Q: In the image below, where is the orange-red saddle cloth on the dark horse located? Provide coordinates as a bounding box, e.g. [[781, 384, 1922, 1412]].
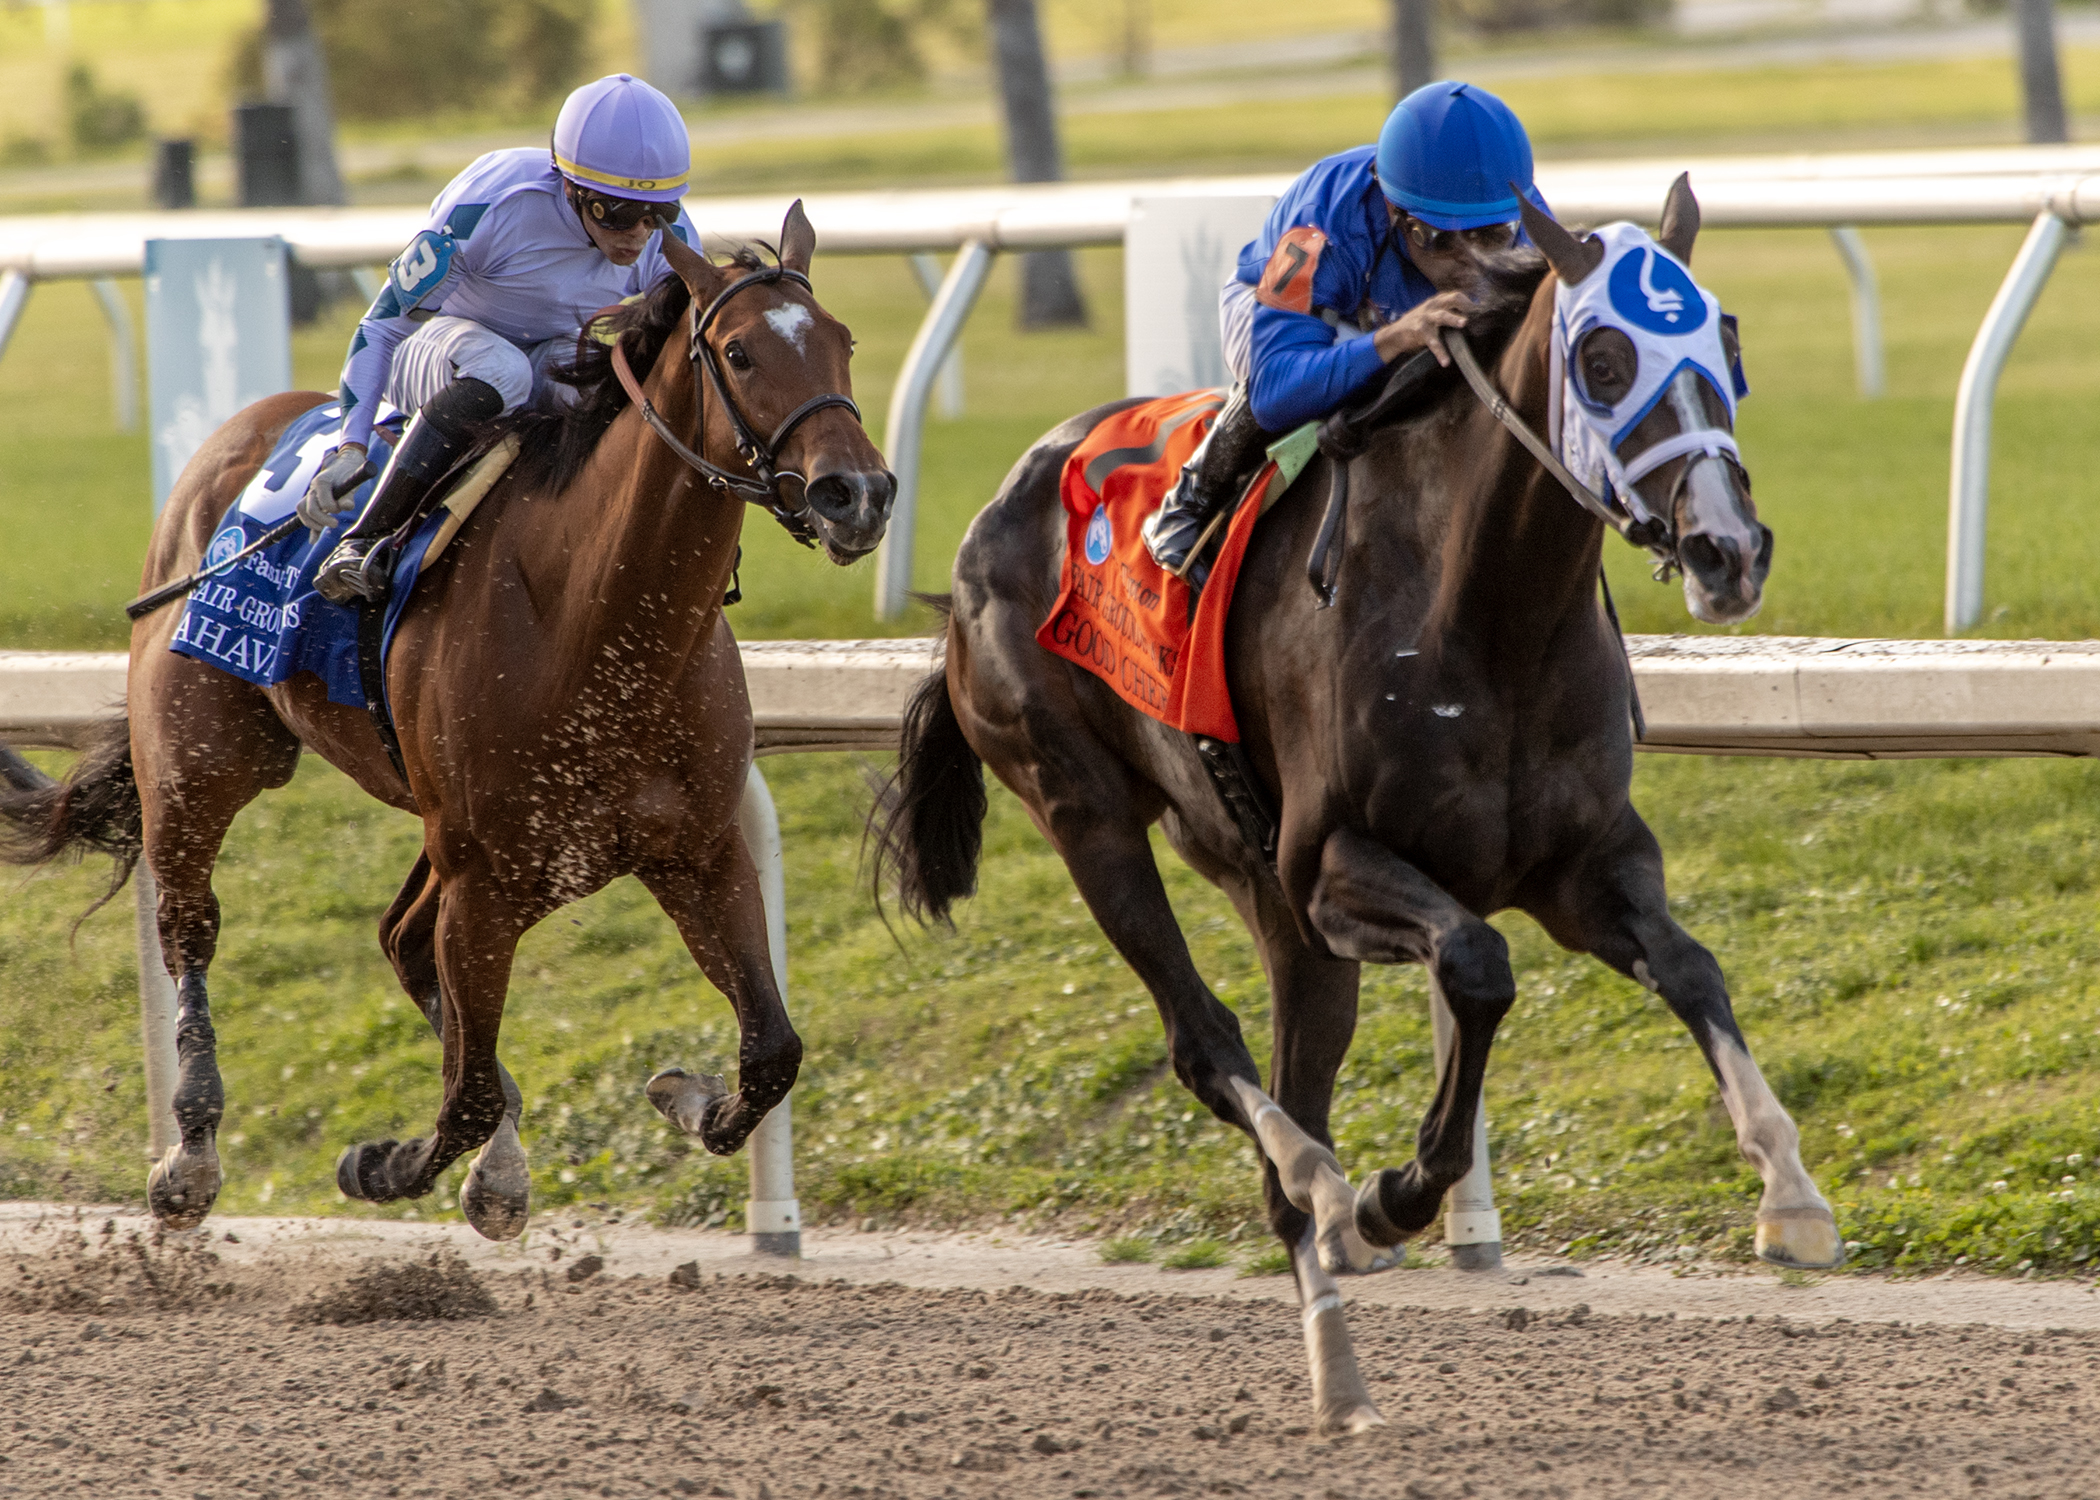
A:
[[1035, 391, 1277, 744]]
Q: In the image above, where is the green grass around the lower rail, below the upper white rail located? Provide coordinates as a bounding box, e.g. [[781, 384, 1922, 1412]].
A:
[[0, 152, 2100, 1273]]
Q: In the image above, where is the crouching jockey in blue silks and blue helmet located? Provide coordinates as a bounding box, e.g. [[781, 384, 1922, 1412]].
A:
[[1145, 82, 1546, 574]]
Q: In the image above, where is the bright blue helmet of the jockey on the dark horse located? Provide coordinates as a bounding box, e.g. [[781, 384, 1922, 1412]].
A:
[[1378, 82, 1537, 229]]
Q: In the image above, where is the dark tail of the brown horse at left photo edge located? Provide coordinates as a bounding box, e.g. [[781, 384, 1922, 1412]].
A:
[[0, 718, 145, 920]]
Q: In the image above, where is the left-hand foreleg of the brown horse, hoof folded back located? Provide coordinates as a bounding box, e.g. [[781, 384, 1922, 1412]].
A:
[[336, 870, 531, 1227]]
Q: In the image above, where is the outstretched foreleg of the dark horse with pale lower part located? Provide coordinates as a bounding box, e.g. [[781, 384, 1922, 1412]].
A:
[[1533, 807, 1844, 1269]]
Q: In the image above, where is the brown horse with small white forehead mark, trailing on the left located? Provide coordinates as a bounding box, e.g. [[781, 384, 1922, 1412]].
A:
[[0, 204, 895, 1237]]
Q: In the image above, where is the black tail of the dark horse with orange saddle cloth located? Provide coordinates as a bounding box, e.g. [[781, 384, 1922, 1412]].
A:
[[867, 599, 985, 926]]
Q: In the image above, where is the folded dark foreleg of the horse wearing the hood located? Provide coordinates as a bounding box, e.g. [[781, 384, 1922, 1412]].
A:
[[1308, 828, 1516, 1246]]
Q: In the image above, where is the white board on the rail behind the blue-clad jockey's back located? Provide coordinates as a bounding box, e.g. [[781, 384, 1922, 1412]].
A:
[[1124, 197, 1277, 395]]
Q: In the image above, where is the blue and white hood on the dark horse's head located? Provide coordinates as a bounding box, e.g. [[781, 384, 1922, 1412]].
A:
[[1548, 223, 1749, 521]]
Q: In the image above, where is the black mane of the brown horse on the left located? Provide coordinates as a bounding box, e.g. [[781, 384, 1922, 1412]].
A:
[[477, 246, 767, 494]]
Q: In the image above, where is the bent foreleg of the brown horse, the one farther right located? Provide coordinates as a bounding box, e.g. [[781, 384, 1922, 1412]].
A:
[[636, 826, 802, 1155]]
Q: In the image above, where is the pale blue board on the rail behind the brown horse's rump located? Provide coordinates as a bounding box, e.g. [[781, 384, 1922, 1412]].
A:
[[145, 239, 292, 515]]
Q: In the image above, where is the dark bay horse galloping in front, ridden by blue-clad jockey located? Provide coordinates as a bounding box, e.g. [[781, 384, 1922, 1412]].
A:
[[876, 181, 1842, 1431]]
